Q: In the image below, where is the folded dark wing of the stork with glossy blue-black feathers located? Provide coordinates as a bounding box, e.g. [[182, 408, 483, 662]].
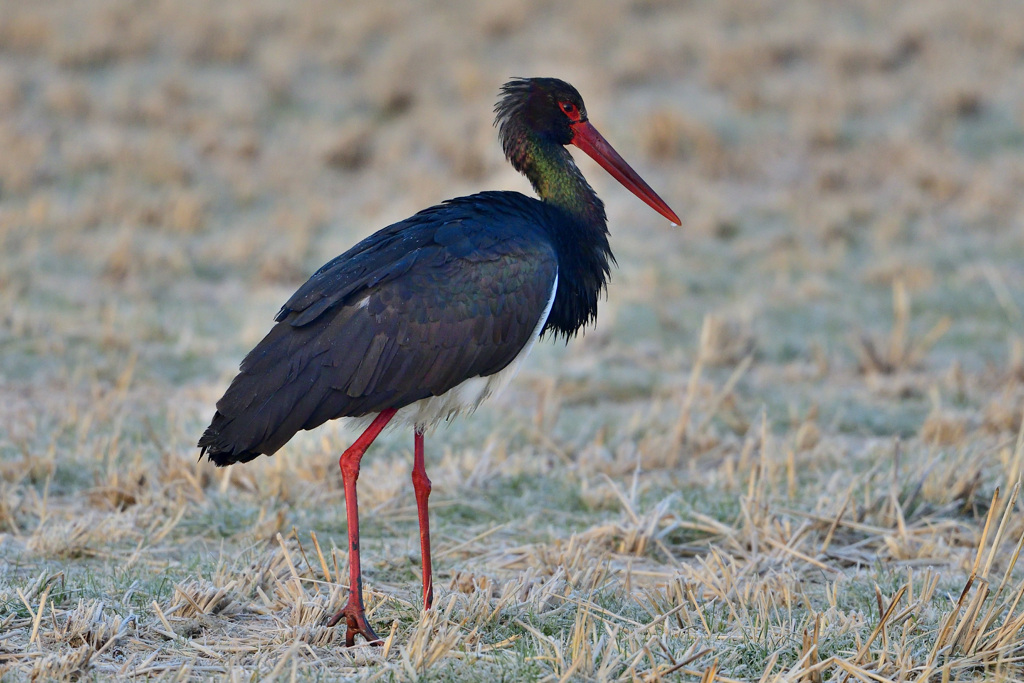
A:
[[199, 193, 557, 465]]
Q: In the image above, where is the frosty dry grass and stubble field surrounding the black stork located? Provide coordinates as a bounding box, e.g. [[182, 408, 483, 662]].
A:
[[0, 0, 1024, 683]]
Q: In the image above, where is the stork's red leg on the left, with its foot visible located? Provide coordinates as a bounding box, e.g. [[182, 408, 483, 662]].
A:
[[327, 408, 397, 647]]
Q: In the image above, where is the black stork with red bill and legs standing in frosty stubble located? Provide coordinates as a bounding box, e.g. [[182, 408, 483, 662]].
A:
[[198, 78, 681, 646]]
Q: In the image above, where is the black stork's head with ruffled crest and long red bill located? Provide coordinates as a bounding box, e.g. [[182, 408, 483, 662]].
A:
[[495, 78, 681, 225]]
